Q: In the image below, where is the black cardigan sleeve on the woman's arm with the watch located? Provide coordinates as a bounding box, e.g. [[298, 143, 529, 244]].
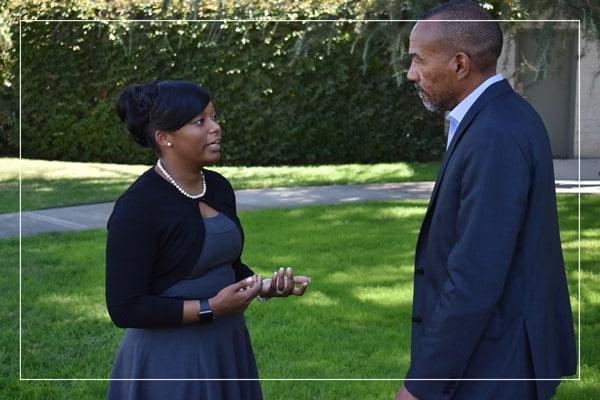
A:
[[106, 201, 183, 328]]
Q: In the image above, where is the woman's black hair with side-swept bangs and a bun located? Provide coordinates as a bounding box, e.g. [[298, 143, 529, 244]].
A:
[[117, 81, 210, 151]]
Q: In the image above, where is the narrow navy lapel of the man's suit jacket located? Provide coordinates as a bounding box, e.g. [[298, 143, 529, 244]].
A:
[[417, 79, 512, 260]]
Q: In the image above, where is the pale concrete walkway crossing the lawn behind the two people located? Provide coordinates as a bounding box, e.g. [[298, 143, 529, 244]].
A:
[[0, 181, 600, 238]]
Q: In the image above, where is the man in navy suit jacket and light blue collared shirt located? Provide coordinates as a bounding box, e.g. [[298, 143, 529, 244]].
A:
[[396, 0, 576, 400]]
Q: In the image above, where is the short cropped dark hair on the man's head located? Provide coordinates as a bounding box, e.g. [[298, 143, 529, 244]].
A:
[[420, 0, 503, 71]]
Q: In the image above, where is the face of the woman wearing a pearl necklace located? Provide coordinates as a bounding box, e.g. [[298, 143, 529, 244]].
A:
[[170, 102, 221, 166]]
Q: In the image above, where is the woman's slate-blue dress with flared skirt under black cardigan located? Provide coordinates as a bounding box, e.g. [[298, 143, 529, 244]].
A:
[[107, 213, 262, 400]]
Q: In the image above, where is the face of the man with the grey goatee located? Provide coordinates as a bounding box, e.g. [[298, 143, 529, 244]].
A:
[[407, 21, 458, 111]]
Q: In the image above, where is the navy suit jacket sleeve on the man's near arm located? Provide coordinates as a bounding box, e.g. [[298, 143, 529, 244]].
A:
[[405, 129, 531, 399]]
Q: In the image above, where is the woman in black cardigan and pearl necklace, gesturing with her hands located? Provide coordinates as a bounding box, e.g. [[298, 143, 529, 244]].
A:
[[106, 81, 310, 400]]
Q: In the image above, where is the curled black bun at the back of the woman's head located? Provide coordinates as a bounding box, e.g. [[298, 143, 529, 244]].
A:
[[117, 83, 158, 147]]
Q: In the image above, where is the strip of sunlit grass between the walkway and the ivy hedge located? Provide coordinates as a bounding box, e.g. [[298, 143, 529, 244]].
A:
[[0, 158, 438, 213]]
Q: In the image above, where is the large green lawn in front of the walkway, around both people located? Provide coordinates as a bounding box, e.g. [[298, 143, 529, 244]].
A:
[[0, 195, 600, 400]]
